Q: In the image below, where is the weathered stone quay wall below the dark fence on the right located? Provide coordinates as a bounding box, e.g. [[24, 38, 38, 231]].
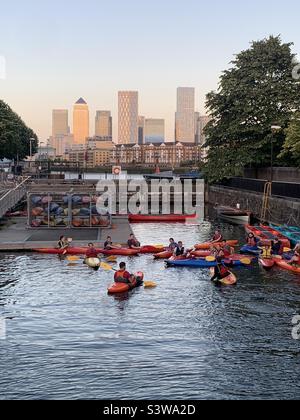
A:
[[206, 186, 300, 226]]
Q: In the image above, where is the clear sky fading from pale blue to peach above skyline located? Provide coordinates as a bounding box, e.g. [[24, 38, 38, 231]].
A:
[[0, 0, 300, 141]]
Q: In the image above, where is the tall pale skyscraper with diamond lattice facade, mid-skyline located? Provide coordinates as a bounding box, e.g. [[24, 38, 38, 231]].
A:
[[118, 91, 139, 144]]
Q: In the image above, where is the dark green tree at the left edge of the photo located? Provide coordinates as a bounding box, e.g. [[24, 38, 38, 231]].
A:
[[0, 100, 38, 160]]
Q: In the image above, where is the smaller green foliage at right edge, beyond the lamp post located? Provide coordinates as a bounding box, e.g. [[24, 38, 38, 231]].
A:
[[281, 112, 300, 167]]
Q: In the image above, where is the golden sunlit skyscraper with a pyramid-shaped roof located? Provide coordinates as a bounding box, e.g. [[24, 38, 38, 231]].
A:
[[73, 98, 90, 144]]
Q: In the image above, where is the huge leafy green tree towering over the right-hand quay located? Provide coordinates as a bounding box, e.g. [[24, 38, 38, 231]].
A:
[[205, 36, 300, 182]]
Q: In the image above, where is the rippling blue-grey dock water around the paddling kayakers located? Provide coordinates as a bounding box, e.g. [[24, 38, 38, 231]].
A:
[[0, 222, 300, 399]]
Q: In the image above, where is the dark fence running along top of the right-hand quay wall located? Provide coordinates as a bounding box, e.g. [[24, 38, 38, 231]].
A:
[[218, 178, 300, 199]]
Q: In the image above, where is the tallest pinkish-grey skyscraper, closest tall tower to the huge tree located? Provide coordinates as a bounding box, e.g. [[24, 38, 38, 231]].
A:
[[175, 87, 195, 143]]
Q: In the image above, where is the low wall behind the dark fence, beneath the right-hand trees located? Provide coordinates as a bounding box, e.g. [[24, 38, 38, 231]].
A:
[[244, 168, 300, 183]]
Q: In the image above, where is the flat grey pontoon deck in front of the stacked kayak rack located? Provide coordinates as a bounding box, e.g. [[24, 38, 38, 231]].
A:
[[0, 217, 132, 252]]
